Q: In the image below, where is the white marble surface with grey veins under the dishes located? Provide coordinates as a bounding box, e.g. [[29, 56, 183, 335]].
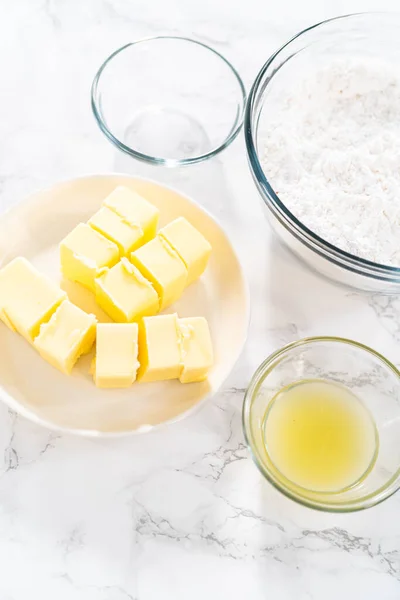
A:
[[0, 0, 400, 600]]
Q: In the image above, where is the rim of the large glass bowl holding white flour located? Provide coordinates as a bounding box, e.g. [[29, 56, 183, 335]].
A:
[[244, 11, 400, 284]]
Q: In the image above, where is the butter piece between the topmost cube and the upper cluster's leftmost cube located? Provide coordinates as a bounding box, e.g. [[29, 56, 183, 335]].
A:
[[88, 206, 143, 256]]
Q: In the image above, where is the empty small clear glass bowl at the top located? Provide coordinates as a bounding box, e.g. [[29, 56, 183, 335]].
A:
[[92, 36, 246, 167]]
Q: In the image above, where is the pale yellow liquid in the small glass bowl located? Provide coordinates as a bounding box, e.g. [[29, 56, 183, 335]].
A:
[[263, 379, 378, 493]]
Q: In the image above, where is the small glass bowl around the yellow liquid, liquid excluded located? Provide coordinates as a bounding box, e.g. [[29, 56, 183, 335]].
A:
[[243, 337, 400, 512]]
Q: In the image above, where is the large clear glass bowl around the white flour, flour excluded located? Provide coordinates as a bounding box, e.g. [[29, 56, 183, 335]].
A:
[[244, 13, 400, 292]]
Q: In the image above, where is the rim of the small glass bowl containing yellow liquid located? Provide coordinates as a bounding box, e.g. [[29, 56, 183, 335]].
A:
[[242, 336, 400, 513]]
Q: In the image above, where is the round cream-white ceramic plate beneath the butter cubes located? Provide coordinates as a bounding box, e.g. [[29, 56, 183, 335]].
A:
[[0, 175, 249, 435]]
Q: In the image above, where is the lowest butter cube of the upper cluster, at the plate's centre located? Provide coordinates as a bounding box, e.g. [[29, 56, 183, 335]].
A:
[[95, 258, 160, 323]]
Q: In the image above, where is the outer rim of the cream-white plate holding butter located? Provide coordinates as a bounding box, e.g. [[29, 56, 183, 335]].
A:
[[0, 171, 251, 439]]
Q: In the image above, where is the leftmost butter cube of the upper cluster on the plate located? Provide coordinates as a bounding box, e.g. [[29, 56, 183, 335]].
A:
[[60, 223, 119, 292]]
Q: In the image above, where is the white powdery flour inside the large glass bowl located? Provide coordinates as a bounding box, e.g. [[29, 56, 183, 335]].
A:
[[262, 61, 400, 266]]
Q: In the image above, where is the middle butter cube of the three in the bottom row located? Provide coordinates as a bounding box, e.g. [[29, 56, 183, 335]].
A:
[[138, 314, 182, 382]]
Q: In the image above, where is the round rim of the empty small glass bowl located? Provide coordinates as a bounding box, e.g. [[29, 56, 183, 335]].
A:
[[91, 35, 246, 167]]
